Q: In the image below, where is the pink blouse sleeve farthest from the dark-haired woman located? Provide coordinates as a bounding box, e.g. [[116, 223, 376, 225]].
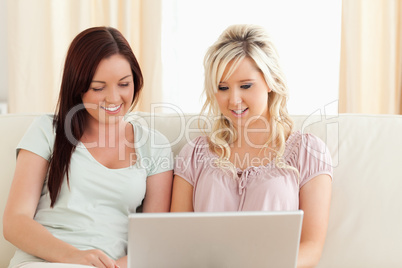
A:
[[299, 134, 333, 188]]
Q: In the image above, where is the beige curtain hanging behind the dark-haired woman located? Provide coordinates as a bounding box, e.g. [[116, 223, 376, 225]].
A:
[[7, 0, 161, 113]]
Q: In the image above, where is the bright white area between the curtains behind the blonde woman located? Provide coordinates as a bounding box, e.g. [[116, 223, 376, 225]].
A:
[[162, 0, 342, 114]]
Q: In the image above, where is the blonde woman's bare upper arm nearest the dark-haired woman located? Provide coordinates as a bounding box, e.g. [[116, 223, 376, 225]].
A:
[[170, 175, 194, 212]]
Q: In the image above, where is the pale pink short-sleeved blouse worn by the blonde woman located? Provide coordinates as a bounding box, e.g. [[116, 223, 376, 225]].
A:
[[174, 131, 332, 212]]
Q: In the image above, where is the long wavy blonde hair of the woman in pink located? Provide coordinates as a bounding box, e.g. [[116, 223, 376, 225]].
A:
[[201, 24, 293, 175]]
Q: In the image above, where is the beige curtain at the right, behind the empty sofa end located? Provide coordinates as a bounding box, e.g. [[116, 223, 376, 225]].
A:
[[339, 0, 402, 114]]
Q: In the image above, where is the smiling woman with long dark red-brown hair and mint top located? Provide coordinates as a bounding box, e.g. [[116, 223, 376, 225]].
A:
[[4, 27, 173, 268]]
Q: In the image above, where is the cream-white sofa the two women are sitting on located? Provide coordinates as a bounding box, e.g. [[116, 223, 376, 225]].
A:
[[0, 113, 402, 268]]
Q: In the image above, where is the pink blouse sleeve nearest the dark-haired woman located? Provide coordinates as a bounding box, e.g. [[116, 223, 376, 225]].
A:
[[174, 137, 204, 186]]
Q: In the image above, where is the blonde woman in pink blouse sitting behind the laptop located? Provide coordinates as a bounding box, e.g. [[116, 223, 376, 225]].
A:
[[171, 25, 332, 267]]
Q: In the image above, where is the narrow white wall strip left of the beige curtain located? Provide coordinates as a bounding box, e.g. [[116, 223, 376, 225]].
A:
[[0, 0, 8, 102]]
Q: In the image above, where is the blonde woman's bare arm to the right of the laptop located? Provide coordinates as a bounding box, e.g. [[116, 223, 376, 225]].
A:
[[297, 174, 332, 268]]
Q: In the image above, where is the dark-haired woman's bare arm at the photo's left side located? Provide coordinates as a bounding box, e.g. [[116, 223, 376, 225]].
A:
[[3, 150, 115, 268]]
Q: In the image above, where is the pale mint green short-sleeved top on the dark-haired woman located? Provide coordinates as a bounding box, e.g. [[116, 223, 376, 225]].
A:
[[10, 115, 173, 267]]
